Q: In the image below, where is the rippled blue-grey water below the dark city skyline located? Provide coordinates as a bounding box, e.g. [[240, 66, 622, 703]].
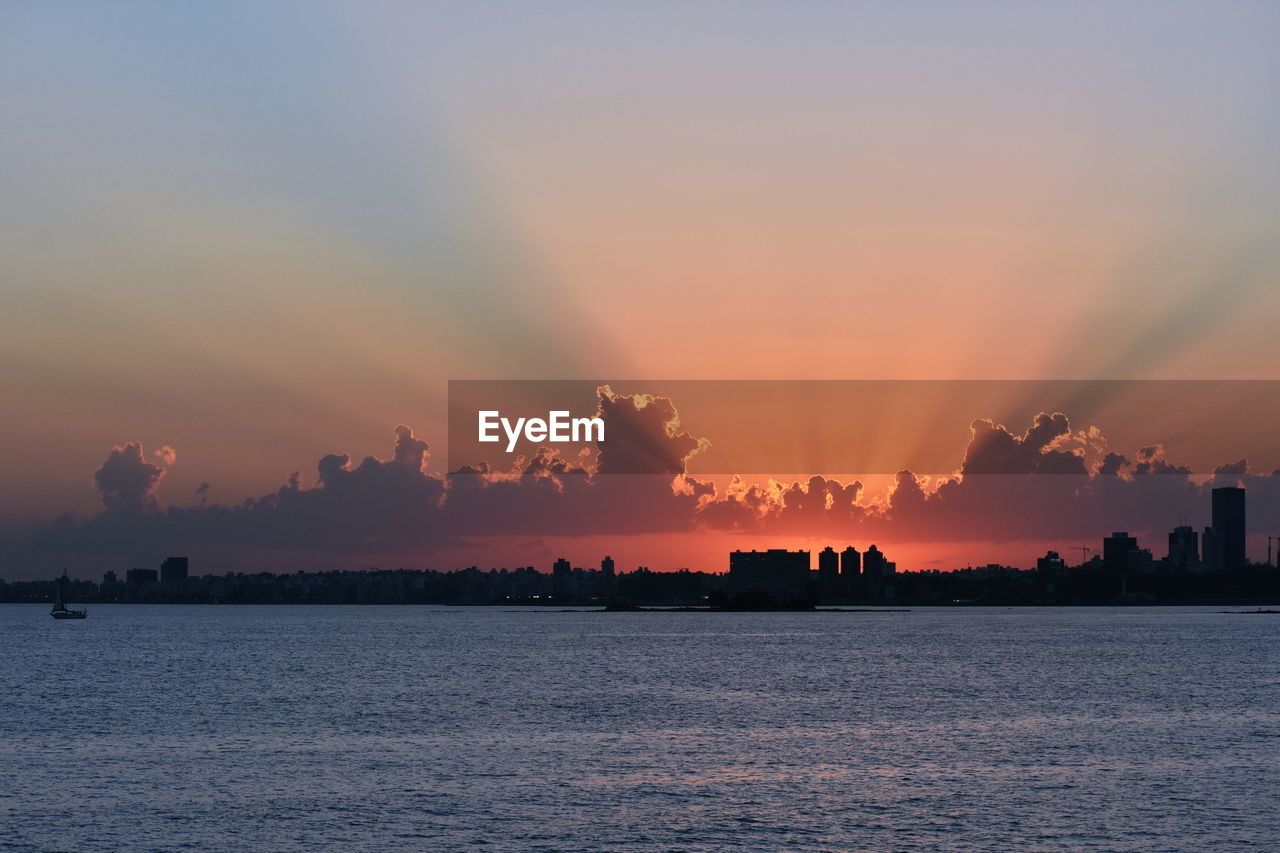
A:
[[0, 605, 1280, 852]]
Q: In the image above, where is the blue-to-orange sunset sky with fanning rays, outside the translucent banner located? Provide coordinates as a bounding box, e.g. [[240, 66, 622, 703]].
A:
[[0, 0, 1280, 575]]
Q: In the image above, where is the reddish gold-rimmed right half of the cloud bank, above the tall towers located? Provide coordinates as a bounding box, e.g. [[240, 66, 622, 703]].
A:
[[698, 412, 1280, 542]]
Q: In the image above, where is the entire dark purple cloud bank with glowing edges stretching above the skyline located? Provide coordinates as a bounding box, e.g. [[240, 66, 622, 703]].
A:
[[9, 388, 1280, 569]]
